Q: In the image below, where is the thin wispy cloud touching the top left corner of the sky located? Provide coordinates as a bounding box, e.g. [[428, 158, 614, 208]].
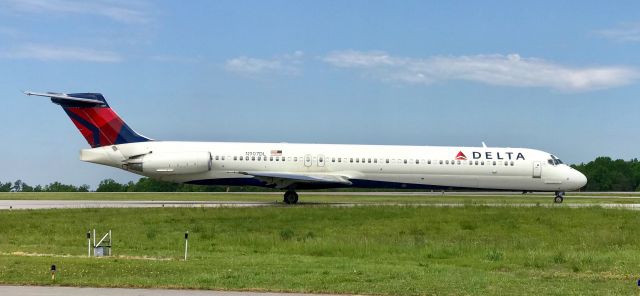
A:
[[6, 0, 150, 23]]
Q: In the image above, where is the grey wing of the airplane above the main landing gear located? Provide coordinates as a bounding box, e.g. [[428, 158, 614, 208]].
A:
[[234, 171, 351, 188]]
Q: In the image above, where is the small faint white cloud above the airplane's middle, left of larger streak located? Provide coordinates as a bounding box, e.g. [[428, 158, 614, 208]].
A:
[[225, 51, 304, 75]]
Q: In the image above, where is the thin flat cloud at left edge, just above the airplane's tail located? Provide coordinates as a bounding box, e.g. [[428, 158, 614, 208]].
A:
[[0, 44, 122, 63]]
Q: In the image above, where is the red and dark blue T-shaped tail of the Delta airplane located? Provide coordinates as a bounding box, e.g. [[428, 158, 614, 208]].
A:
[[25, 92, 151, 148]]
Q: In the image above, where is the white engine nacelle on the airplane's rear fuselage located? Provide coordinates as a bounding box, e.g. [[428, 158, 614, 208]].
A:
[[125, 151, 213, 175]]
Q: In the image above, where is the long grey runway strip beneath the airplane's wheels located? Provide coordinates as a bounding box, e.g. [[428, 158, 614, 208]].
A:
[[0, 200, 640, 210]]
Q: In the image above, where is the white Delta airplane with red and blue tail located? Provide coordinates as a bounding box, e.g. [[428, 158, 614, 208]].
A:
[[24, 92, 587, 204]]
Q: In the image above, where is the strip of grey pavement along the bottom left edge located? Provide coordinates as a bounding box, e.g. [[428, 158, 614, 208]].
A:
[[0, 286, 342, 296]]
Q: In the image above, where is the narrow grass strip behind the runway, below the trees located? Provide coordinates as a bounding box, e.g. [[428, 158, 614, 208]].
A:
[[0, 191, 640, 205]]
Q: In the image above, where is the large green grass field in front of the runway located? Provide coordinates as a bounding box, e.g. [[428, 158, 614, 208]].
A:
[[0, 206, 640, 295]]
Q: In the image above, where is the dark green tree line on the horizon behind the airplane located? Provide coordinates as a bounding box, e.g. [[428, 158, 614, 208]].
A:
[[0, 157, 640, 192]]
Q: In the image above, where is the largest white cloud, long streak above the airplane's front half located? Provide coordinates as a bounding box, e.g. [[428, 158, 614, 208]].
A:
[[323, 50, 639, 91]]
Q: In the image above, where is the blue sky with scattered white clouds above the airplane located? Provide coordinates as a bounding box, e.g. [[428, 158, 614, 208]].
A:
[[0, 0, 640, 189]]
